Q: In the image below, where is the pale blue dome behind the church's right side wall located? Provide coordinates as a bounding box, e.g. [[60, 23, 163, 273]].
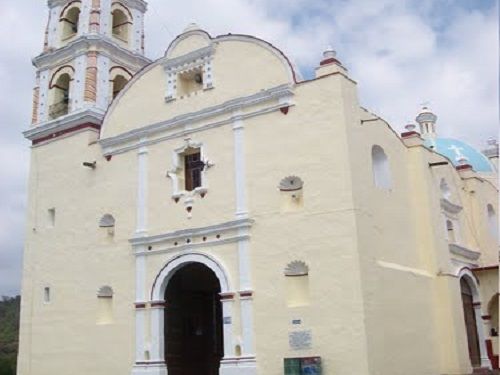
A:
[[425, 138, 494, 172]]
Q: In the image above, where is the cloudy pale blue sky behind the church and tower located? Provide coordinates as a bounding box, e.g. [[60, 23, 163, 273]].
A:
[[0, 0, 499, 296]]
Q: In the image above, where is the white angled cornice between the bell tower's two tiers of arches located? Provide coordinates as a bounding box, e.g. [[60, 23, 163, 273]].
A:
[[32, 34, 151, 69]]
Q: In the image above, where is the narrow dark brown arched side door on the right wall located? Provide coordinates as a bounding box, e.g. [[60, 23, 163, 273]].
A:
[[460, 277, 481, 367]]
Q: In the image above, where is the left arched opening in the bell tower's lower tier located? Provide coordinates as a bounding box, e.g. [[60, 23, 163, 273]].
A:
[[49, 66, 74, 120]]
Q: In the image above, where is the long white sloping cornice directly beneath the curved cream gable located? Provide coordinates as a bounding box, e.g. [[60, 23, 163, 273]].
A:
[[99, 84, 293, 155]]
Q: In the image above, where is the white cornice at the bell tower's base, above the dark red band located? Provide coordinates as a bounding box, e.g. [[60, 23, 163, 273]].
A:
[[23, 108, 104, 141]]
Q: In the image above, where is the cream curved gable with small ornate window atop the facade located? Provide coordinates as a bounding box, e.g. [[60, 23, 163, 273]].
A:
[[101, 29, 297, 140]]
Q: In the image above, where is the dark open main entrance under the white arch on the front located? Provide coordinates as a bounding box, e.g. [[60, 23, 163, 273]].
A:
[[164, 263, 224, 375]]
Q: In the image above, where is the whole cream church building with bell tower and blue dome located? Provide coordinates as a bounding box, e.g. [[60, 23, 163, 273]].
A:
[[18, 0, 499, 375]]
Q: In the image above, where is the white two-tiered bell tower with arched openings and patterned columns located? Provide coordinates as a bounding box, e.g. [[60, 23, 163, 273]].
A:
[[24, 0, 150, 145]]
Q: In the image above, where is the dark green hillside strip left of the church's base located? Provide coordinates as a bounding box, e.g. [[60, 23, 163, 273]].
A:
[[0, 296, 21, 375]]
